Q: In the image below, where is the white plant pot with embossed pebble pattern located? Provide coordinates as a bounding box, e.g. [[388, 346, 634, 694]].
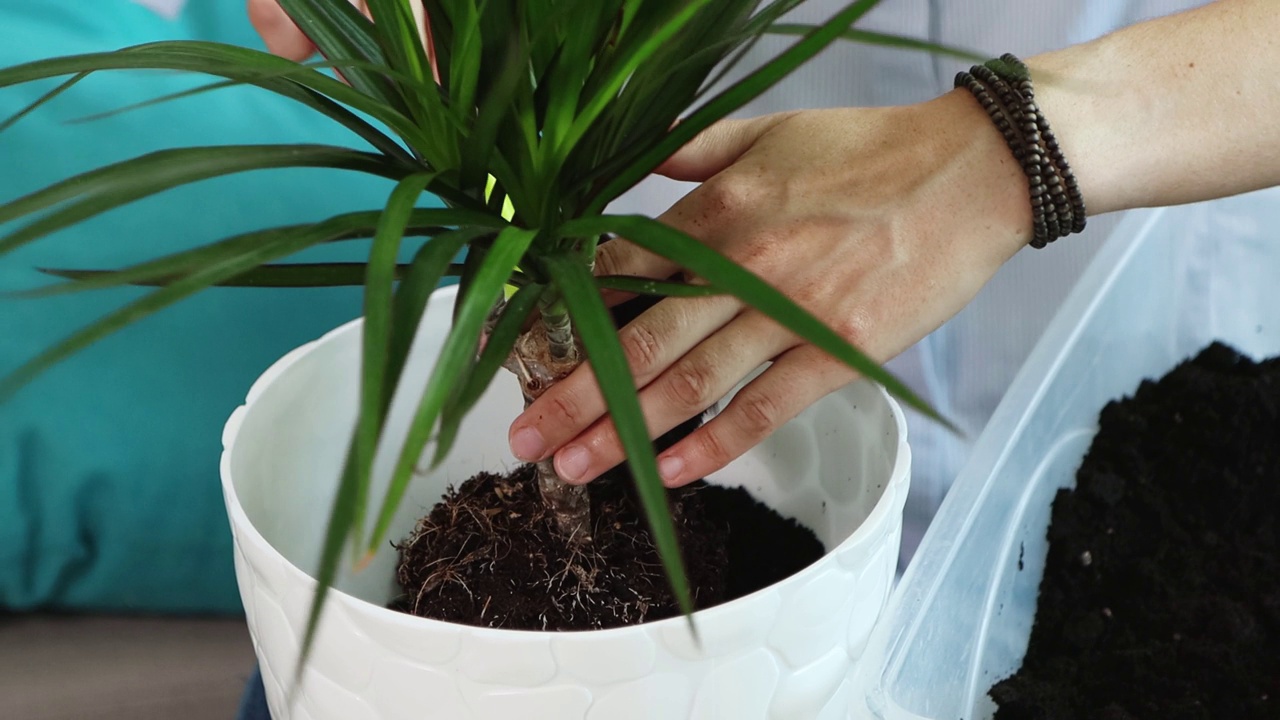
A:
[[221, 287, 910, 720]]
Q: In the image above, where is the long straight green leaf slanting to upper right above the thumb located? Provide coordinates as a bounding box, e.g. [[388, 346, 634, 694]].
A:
[[584, 0, 879, 215]]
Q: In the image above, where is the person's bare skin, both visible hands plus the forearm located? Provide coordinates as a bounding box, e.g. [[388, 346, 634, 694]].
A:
[[250, 0, 1280, 486]]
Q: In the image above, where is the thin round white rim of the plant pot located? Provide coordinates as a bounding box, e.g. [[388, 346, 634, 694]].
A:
[[219, 284, 911, 639]]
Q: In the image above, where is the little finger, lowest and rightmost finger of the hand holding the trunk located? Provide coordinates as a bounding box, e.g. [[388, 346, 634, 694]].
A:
[[658, 346, 856, 487]]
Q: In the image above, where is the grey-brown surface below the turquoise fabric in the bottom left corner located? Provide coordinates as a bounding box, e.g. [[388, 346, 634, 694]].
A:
[[0, 615, 253, 720]]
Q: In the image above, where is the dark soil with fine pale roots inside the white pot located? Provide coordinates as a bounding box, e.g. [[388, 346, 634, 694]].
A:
[[392, 285, 824, 630]]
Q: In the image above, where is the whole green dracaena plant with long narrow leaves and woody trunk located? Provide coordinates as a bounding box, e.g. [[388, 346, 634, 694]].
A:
[[0, 0, 962, 661]]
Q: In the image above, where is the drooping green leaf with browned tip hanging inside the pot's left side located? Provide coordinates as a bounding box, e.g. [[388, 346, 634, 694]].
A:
[[369, 227, 538, 551]]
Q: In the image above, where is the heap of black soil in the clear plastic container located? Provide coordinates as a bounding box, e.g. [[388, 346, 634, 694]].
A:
[[991, 343, 1280, 720]]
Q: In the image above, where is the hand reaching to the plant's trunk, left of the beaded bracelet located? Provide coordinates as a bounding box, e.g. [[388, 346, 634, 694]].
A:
[[509, 91, 1032, 487]]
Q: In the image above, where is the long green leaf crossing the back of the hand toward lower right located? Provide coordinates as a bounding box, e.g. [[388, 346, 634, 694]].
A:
[[558, 215, 955, 429]]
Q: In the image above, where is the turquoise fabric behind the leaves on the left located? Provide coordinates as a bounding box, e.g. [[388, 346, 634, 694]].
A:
[[0, 0, 435, 612]]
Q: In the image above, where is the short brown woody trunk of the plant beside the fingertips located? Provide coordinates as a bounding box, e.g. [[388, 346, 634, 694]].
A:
[[506, 302, 591, 544]]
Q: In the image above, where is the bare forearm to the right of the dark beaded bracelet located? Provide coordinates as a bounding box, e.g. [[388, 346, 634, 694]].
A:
[[1028, 0, 1280, 214]]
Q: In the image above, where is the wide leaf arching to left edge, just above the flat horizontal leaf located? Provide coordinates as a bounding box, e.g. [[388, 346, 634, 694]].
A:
[[0, 145, 406, 255]]
